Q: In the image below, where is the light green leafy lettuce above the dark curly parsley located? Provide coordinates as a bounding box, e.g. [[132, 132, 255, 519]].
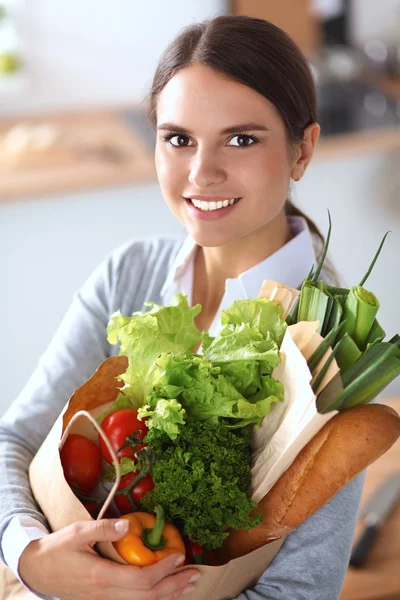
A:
[[107, 294, 286, 439]]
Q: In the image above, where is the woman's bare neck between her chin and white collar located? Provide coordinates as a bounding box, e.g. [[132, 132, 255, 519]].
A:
[[195, 211, 292, 310]]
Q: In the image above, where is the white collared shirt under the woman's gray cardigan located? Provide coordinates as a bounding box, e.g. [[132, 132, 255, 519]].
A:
[[161, 217, 316, 336]]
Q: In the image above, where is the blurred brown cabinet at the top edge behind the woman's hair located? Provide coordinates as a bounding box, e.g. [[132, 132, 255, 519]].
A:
[[230, 0, 321, 57]]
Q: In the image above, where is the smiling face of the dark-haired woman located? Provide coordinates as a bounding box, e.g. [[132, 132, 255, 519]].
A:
[[155, 65, 294, 246]]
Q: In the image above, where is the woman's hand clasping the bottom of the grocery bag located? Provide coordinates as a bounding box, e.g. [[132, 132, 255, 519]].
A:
[[18, 519, 199, 600]]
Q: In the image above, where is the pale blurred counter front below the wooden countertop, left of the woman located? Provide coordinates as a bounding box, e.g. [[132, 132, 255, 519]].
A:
[[0, 185, 183, 415]]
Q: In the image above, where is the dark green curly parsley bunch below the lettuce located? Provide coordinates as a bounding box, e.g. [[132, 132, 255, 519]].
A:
[[142, 418, 262, 548]]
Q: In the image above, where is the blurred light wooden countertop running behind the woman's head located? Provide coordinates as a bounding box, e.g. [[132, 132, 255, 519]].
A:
[[0, 78, 400, 202]]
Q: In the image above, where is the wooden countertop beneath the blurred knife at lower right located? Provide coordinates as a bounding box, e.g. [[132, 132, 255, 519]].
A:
[[339, 398, 400, 600]]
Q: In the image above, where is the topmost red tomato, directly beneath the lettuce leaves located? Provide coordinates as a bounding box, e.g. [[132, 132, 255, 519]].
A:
[[99, 408, 148, 464]]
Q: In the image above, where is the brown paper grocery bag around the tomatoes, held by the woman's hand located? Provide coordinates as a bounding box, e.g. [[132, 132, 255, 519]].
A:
[[29, 356, 284, 600]]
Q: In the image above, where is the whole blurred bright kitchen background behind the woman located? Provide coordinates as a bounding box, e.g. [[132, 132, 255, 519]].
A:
[[0, 0, 400, 600]]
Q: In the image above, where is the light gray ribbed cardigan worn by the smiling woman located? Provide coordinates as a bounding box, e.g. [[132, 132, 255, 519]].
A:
[[0, 237, 365, 600]]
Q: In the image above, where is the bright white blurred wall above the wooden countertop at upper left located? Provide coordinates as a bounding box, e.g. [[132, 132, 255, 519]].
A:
[[0, 0, 226, 115]]
